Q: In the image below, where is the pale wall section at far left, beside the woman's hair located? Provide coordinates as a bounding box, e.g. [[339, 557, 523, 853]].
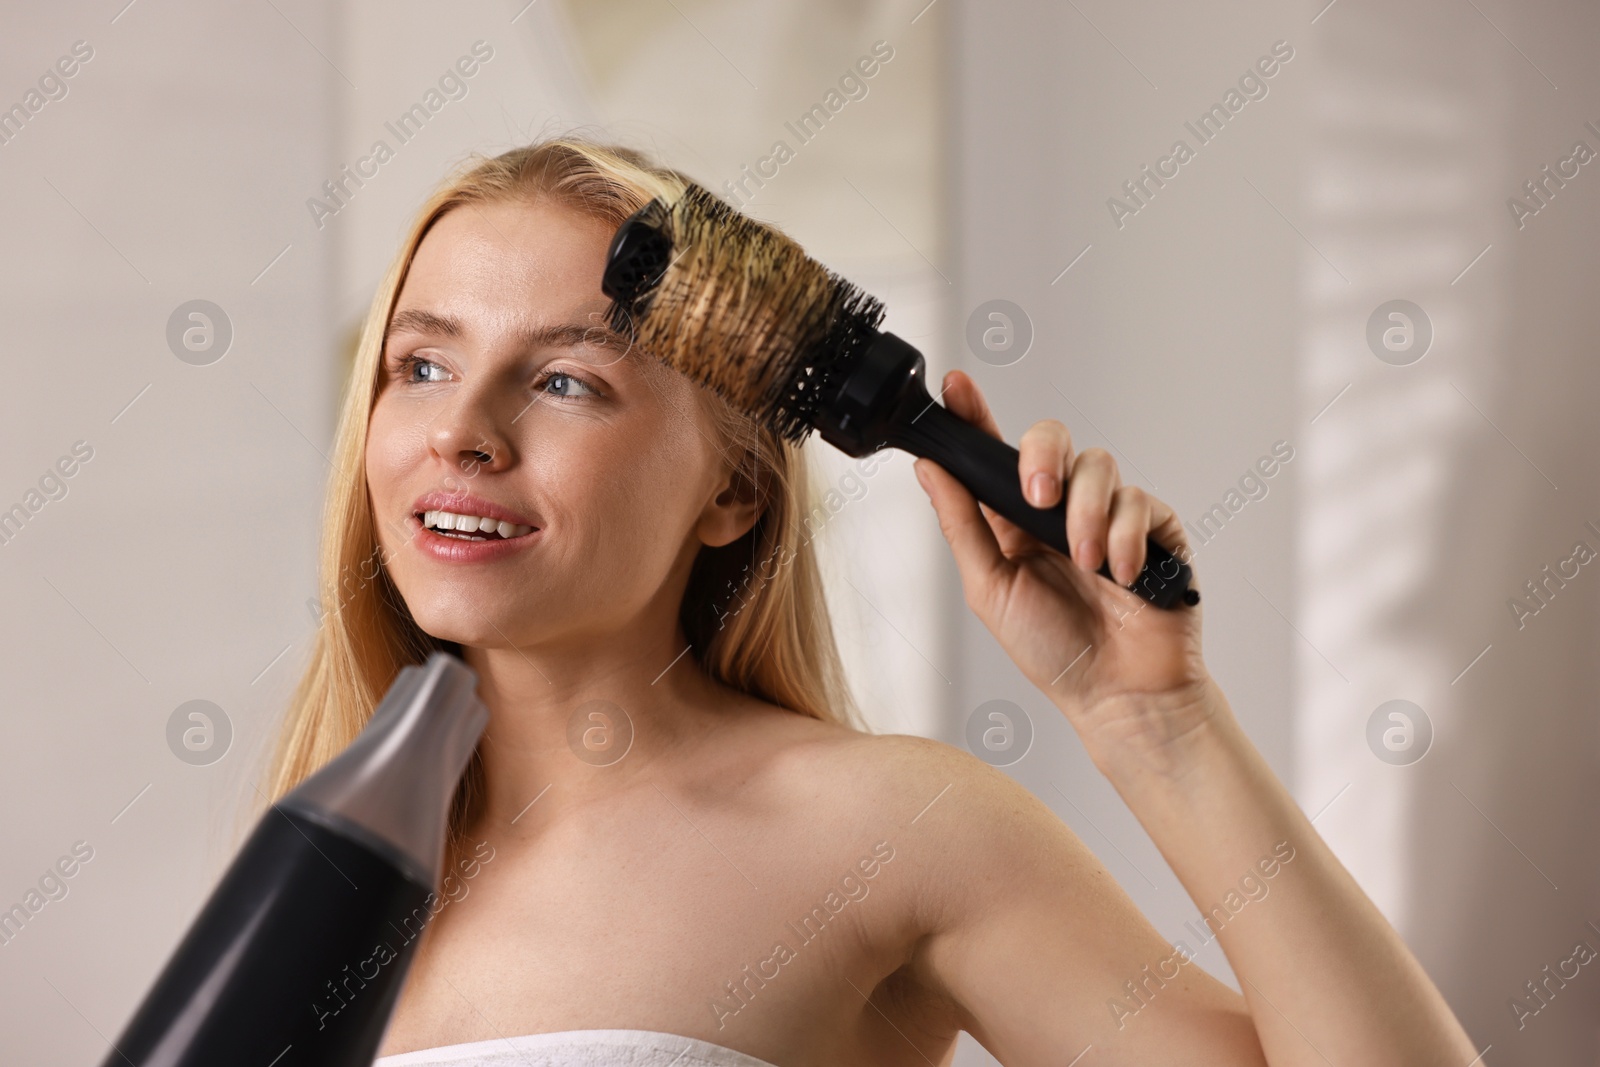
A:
[[0, 0, 344, 1065]]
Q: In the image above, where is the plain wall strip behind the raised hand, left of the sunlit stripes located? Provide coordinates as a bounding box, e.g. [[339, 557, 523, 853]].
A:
[[952, 3, 1315, 1062]]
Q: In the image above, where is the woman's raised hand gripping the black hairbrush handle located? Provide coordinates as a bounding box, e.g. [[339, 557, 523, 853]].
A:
[[914, 371, 1213, 763]]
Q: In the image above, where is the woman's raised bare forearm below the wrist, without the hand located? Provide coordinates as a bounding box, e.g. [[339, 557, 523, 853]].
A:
[[1091, 683, 1477, 1067]]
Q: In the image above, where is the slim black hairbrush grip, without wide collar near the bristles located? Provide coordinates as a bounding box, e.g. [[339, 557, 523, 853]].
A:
[[886, 398, 1200, 608]]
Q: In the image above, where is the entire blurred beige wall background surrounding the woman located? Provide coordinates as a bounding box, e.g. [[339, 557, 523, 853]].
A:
[[0, 0, 1600, 1067]]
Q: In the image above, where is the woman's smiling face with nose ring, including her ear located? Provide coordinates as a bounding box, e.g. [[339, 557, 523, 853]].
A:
[[366, 200, 755, 651]]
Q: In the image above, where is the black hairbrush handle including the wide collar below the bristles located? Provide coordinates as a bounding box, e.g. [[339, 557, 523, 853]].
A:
[[818, 333, 1200, 608]]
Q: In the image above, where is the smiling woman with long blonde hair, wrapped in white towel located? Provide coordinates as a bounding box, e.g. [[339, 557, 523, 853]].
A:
[[262, 141, 1475, 1067]]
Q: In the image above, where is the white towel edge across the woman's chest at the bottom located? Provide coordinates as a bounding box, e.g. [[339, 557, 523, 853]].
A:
[[373, 1030, 776, 1067]]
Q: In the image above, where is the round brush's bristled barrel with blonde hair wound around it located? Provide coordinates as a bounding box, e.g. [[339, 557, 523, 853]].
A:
[[617, 184, 883, 443]]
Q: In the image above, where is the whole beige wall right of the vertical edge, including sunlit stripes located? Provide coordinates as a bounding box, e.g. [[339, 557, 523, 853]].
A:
[[952, 0, 1600, 1067]]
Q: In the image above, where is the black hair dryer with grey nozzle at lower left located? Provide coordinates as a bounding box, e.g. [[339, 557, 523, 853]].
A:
[[102, 653, 488, 1067]]
